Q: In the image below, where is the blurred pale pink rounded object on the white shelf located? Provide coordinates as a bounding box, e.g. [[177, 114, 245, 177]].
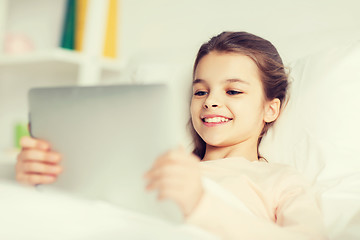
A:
[[4, 34, 34, 54]]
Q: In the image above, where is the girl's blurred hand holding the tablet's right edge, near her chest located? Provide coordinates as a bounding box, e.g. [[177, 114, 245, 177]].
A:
[[145, 148, 204, 216]]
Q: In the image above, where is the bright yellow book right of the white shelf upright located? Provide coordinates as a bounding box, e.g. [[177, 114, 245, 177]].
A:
[[103, 0, 118, 58]]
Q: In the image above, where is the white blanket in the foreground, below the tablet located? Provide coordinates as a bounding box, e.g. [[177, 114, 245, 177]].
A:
[[0, 164, 218, 240]]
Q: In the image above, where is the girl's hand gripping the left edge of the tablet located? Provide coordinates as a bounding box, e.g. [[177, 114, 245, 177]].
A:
[[16, 137, 62, 185]]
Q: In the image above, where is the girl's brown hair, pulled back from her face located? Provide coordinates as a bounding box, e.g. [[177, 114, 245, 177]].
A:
[[189, 32, 288, 159]]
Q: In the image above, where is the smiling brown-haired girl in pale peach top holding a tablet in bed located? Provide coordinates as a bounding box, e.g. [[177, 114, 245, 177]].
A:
[[16, 32, 325, 239]]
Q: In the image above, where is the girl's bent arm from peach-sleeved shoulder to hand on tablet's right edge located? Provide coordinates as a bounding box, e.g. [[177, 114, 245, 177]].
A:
[[146, 149, 326, 240]]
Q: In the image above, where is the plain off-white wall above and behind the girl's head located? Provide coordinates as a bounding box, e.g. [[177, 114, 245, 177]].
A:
[[122, 0, 360, 61]]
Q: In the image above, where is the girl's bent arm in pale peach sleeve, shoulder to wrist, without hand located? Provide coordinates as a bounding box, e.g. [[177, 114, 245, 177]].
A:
[[186, 174, 327, 240]]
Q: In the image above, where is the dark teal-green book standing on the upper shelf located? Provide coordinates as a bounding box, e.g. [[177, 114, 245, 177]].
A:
[[60, 0, 76, 49]]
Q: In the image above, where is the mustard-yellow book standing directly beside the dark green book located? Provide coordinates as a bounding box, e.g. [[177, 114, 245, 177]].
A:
[[75, 0, 88, 51]]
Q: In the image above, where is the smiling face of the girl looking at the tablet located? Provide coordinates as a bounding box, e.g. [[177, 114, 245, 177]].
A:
[[190, 52, 268, 147]]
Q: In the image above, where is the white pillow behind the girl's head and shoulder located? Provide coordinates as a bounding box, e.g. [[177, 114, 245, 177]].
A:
[[260, 41, 360, 185]]
